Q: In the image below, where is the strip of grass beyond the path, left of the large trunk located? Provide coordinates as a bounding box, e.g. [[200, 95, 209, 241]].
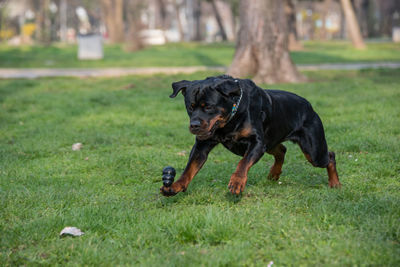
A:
[[0, 43, 234, 68]]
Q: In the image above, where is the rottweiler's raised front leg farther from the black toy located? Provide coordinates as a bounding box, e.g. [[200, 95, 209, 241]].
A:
[[228, 139, 264, 195]]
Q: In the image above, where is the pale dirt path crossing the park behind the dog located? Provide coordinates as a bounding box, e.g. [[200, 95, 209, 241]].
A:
[[0, 62, 400, 79]]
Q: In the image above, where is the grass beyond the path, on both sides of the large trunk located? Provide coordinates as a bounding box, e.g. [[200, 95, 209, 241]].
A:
[[0, 41, 400, 68]]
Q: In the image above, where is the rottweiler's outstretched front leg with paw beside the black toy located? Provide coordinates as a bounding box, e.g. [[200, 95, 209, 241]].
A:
[[160, 140, 218, 197]]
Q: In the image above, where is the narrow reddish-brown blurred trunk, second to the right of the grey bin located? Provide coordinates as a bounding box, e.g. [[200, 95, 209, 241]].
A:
[[125, 0, 144, 52]]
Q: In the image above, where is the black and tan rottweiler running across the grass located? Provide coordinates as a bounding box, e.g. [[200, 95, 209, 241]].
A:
[[160, 75, 341, 196]]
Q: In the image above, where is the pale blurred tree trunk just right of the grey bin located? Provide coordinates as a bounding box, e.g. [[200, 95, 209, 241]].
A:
[[101, 0, 124, 43]]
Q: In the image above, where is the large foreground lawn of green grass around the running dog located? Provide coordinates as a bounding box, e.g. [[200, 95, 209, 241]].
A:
[[0, 70, 400, 266]]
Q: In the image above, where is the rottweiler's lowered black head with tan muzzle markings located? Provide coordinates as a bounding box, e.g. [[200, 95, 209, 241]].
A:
[[170, 75, 241, 140]]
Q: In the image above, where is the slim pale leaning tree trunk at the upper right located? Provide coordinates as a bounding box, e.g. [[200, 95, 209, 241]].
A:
[[340, 0, 365, 49]]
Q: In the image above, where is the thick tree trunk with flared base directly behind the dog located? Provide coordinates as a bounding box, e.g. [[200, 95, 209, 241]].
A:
[[228, 0, 305, 83]]
